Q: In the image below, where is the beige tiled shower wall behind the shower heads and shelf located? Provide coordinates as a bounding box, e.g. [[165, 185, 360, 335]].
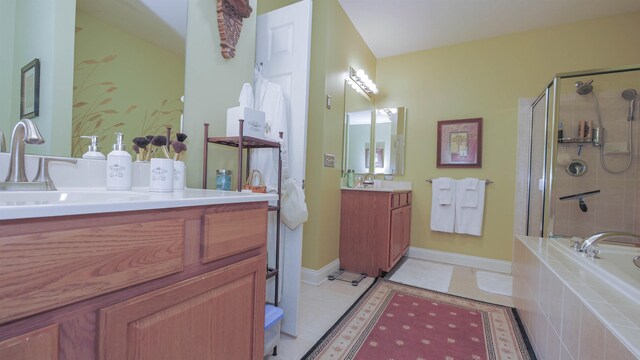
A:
[[553, 73, 640, 237]]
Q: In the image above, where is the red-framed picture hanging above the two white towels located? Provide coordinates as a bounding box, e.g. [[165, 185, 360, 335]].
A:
[[436, 118, 482, 168]]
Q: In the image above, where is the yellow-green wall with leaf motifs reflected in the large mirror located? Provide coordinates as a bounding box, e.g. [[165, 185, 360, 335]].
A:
[[71, 12, 184, 157]]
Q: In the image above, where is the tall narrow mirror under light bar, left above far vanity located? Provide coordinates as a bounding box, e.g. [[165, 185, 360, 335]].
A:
[[342, 81, 373, 174]]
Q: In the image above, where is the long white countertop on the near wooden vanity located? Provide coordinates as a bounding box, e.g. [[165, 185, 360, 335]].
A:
[[0, 188, 278, 220]]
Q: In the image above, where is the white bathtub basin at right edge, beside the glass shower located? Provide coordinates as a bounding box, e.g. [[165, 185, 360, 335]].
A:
[[549, 238, 640, 303]]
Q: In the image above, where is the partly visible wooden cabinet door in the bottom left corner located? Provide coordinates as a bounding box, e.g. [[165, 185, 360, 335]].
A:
[[0, 325, 58, 360]]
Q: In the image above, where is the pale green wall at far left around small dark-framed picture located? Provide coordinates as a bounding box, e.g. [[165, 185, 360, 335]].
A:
[[0, 0, 75, 156]]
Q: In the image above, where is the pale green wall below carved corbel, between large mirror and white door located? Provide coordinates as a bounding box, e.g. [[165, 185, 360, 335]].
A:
[[184, 0, 256, 188]]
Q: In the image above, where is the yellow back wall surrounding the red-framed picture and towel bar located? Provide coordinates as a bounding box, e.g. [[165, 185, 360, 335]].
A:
[[376, 12, 640, 260]]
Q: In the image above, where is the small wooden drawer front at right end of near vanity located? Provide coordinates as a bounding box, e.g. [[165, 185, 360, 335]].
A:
[[201, 206, 267, 263]]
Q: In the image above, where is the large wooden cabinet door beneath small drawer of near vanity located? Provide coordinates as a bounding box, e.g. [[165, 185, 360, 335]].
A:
[[98, 255, 266, 360]]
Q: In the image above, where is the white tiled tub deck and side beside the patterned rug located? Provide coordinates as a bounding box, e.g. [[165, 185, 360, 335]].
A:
[[513, 236, 640, 360]]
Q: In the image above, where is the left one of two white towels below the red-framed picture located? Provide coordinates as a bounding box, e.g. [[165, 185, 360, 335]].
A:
[[431, 178, 456, 233]]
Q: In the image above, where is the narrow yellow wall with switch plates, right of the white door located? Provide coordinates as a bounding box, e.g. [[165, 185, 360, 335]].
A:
[[302, 0, 375, 269]]
